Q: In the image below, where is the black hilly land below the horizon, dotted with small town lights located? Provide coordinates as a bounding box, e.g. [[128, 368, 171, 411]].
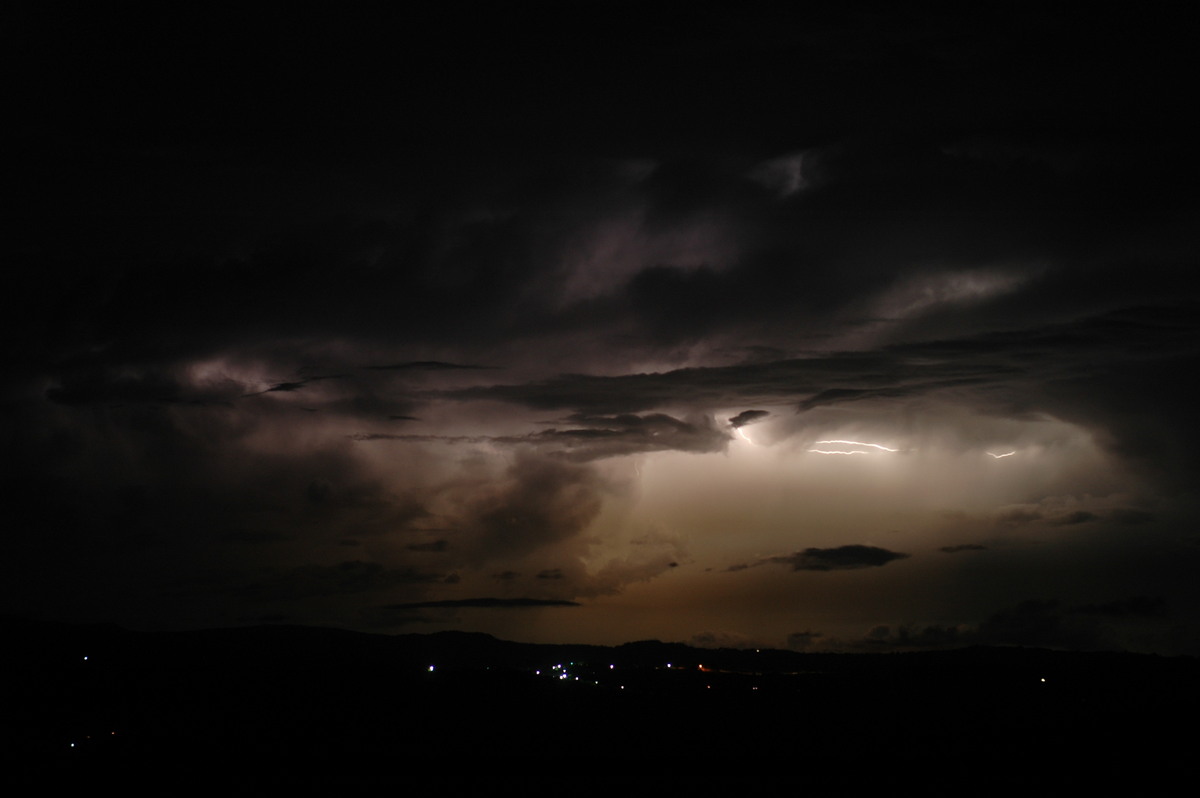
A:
[[0, 612, 1200, 794]]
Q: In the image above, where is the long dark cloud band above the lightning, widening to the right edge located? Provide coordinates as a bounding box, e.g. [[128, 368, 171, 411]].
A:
[[446, 306, 1200, 467]]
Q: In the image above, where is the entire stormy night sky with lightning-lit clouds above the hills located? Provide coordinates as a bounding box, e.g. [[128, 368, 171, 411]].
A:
[[9, 2, 1200, 654]]
